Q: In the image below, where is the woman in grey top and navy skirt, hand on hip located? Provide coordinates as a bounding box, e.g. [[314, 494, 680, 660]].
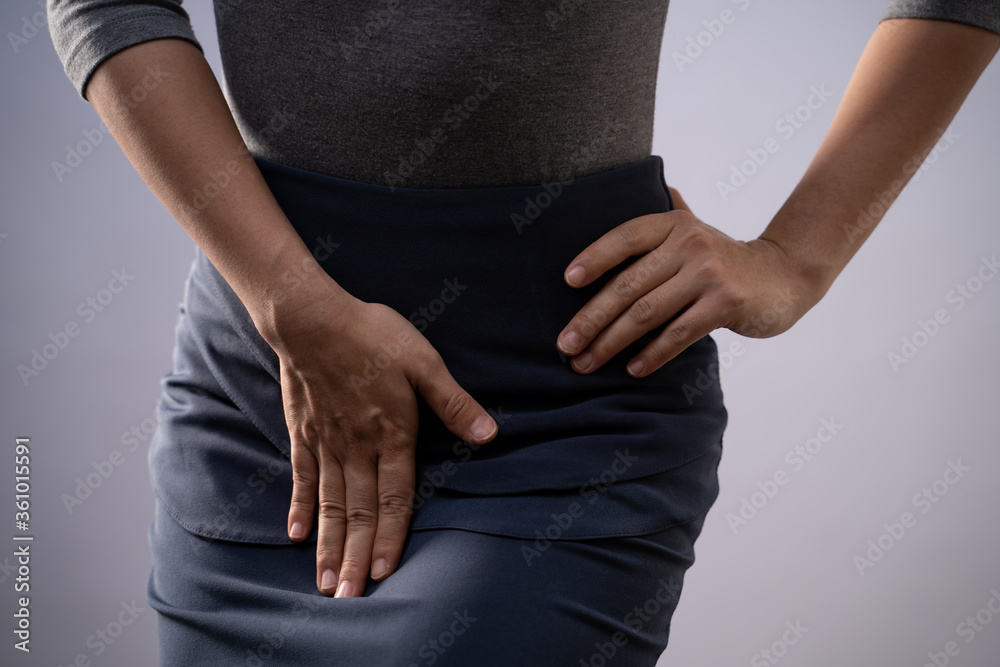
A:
[[49, 0, 1000, 665]]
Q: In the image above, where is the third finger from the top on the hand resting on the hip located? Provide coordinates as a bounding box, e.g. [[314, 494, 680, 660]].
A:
[[572, 277, 702, 373]]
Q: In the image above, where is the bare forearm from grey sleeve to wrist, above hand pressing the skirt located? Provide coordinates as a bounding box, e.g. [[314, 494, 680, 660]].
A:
[[85, 39, 347, 342]]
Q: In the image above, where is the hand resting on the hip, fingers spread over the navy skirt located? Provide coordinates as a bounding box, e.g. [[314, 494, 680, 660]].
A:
[[557, 188, 828, 377]]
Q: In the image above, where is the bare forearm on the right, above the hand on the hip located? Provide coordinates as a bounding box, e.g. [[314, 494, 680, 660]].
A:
[[760, 19, 1000, 300]]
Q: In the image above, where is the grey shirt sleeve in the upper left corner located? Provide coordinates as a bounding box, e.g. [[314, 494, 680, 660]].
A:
[[45, 0, 204, 99]]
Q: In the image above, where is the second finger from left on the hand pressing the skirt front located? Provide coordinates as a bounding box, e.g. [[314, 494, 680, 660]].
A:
[[316, 457, 347, 595]]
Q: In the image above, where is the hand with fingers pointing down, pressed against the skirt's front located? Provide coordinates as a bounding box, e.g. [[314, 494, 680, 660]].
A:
[[265, 271, 497, 597]]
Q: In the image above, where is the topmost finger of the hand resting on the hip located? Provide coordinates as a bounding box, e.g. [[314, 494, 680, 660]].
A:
[[564, 213, 671, 287]]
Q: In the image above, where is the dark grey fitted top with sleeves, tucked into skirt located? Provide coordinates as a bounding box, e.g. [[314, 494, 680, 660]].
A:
[[47, 0, 1000, 188]]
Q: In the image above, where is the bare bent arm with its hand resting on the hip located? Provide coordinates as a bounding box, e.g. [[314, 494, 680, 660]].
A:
[[558, 18, 1000, 377]]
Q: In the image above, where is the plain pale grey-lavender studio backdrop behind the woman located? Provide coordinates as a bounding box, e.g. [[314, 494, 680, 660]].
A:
[[0, 0, 1000, 667]]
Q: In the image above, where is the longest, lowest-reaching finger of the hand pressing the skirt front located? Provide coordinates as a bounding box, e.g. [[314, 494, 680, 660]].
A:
[[336, 455, 378, 598]]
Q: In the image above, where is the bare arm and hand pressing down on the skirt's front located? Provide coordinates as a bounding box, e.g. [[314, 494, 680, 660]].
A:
[[84, 38, 497, 597]]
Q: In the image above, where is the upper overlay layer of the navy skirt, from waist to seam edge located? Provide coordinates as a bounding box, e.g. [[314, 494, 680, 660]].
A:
[[152, 155, 727, 539]]
